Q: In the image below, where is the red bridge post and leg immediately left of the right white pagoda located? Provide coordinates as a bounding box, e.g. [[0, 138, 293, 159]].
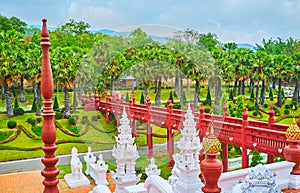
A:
[[166, 100, 175, 168]]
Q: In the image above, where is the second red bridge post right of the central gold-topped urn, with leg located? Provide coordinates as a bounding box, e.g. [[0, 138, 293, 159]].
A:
[[242, 107, 249, 168]]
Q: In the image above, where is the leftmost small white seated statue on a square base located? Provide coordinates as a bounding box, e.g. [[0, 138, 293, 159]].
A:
[[64, 147, 90, 188]]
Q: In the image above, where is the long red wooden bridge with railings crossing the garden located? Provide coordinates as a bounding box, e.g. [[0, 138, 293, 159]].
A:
[[82, 95, 300, 172]]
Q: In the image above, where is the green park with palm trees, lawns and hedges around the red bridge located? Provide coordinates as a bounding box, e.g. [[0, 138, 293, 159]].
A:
[[0, 15, 300, 170]]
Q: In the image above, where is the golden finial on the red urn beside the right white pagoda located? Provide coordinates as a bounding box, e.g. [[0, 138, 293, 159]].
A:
[[203, 121, 221, 153]]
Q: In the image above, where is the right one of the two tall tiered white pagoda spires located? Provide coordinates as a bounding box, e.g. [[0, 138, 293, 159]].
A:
[[169, 106, 203, 193]]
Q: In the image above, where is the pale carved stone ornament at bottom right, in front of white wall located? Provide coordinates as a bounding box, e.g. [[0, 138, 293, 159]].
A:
[[232, 164, 281, 193]]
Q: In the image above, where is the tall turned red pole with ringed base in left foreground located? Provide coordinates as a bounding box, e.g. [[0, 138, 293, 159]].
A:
[[41, 19, 59, 193]]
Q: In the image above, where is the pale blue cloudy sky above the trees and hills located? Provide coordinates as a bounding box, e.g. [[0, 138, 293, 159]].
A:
[[0, 0, 300, 44]]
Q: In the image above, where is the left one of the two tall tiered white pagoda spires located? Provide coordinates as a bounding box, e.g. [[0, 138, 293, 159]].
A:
[[111, 108, 141, 193]]
